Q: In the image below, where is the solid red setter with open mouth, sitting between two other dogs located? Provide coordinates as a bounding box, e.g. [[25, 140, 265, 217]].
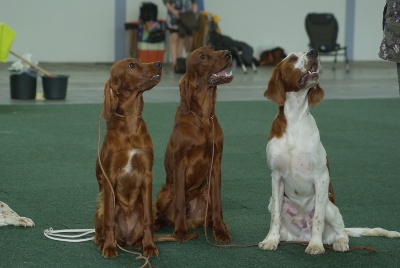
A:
[[155, 47, 233, 242]]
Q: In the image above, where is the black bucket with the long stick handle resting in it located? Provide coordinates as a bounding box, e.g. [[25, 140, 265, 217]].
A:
[[42, 75, 68, 100]]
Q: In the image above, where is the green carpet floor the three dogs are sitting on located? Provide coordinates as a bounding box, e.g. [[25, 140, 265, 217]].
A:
[[0, 99, 400, 267]]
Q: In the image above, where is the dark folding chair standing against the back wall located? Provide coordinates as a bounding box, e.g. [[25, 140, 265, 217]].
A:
[[305, 13, 350, 72]]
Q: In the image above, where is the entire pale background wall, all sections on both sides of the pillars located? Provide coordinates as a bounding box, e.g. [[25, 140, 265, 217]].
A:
[[0, 0, 385, 62]]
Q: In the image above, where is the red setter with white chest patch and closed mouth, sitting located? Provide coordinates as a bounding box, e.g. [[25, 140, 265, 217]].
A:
[[95, 58, 162, 258]]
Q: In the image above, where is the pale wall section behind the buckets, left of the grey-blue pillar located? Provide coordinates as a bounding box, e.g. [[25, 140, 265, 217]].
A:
[[0, 0, 114, 62]]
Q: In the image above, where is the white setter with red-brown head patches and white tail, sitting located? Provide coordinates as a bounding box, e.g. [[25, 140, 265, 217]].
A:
[[259, 50, 400, 254]]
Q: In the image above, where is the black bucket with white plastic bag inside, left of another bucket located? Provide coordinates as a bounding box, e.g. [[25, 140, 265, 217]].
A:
[[10, 72, 37, 100]]
